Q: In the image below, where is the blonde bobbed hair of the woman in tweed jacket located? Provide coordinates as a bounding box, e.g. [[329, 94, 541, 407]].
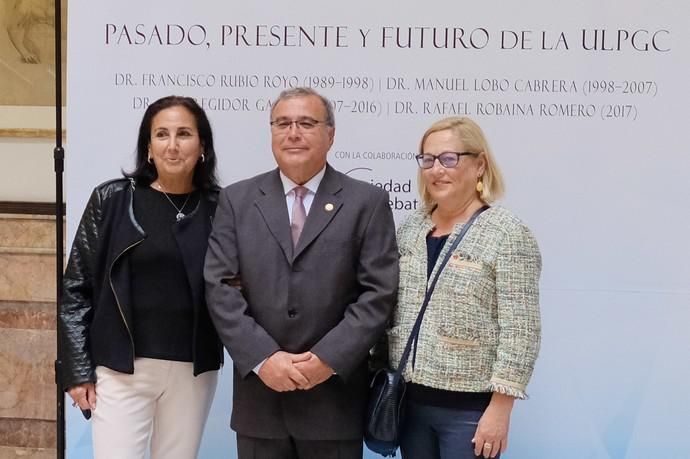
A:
[[417, 116, 505, 212]]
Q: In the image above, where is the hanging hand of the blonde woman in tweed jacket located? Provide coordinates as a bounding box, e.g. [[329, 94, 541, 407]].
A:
[[472, 392, 515, 458]]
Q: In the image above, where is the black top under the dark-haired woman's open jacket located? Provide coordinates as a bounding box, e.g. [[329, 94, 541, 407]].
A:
[[131, 187, 200, 362]]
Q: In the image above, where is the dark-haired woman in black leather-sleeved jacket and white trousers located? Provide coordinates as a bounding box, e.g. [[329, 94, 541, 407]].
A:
[[58, 96, 223, 459]]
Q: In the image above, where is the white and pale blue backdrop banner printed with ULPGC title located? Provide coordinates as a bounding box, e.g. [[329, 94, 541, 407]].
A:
[[66, 0, 690, 459]]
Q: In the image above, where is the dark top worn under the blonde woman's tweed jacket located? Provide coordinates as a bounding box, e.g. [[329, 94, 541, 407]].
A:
[[407, 234, 491, 411]]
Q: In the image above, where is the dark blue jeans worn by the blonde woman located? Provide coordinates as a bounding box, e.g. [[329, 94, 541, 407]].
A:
[[400, 401, 500, 459]]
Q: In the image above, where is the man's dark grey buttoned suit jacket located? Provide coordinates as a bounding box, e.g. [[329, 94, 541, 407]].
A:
[[204, 166, 398, 440]]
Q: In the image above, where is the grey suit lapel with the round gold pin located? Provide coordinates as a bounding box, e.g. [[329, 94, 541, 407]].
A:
[[288, 166, 343, 259]]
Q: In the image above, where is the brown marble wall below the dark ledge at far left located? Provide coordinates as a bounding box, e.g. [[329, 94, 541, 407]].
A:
[[0, 214, 56, 459]]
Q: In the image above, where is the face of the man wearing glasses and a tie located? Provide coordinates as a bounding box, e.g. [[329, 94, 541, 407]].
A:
[[271, 96, 335, 184]]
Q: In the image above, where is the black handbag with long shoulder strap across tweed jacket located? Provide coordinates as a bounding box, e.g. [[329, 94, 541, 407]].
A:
[[364, 206, 489, 457]]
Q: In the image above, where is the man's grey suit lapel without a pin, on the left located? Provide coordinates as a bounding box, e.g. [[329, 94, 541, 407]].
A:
[[255, 169, 293, 262]]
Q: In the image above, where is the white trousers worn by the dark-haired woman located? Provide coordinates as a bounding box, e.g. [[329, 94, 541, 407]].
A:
[[91, 358, 218, 459]]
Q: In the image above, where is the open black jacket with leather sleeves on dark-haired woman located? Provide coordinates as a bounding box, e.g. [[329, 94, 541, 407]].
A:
[[58, 179, 223, 389]]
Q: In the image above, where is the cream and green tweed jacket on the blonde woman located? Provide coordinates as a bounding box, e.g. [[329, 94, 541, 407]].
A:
[[388, 207, 541, 398]]
